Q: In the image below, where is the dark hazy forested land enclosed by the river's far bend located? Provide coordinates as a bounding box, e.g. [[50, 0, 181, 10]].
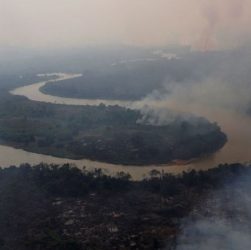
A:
[[41, 59, 184, 100]]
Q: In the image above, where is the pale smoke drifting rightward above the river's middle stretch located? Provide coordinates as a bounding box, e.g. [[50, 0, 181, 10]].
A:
[[135, 48, 251, 122]]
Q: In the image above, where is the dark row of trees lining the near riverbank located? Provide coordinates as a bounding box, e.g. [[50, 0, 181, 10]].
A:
[[0, 163, 247, 197]]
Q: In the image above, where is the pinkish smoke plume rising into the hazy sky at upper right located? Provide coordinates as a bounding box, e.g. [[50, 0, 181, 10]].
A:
[[198, 0, 250, 51]]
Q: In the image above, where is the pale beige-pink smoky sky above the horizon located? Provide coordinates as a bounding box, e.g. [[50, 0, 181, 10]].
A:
[[0, 0, 251, 49]]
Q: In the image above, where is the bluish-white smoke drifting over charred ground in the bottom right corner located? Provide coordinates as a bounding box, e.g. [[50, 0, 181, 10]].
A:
[[176, 175, 251, 250]]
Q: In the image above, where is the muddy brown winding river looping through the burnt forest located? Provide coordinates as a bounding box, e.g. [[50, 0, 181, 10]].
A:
[[0, 73, 251, 179]]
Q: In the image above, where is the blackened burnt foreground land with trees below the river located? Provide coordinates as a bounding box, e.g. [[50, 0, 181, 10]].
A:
[[0, 164, 248, 250]]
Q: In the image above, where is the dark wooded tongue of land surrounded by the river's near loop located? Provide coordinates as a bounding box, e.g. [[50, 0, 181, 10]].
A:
[[0, 75, 227, 166]]
